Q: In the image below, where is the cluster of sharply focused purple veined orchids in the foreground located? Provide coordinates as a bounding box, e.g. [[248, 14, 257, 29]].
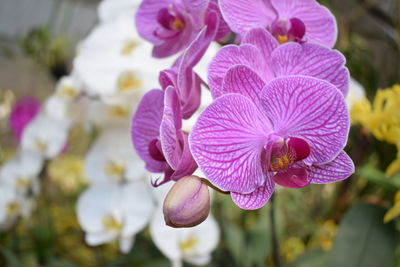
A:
[[132, 0, 354, 215]]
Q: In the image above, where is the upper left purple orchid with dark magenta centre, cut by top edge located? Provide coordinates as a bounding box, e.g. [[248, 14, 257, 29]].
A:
[[136, 0, 229, 58]]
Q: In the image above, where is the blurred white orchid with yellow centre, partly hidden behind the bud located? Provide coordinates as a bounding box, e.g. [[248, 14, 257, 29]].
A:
[[150, 206, 220, 267]]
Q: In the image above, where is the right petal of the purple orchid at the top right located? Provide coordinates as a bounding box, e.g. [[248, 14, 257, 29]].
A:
[[270, 0, 337, 47]]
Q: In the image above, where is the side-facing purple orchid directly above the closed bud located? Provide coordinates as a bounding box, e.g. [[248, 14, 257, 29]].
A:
[[132, 86, 197, 186]]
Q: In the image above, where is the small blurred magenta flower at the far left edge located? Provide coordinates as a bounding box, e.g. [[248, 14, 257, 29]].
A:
[[9, 97, 40, 142]]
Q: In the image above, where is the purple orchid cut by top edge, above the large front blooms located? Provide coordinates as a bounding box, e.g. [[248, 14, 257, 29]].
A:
[[220, 0, 337, 47]]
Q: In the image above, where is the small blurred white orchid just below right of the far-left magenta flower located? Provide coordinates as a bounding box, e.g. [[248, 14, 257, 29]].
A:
[[21, 112, 69, 159]]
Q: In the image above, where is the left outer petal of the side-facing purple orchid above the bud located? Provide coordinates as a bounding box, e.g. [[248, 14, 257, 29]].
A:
[[132, 89, 166, 172]]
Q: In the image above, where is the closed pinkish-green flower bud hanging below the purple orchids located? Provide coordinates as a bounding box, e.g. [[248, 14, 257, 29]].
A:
[[163, 176, 210, 228]]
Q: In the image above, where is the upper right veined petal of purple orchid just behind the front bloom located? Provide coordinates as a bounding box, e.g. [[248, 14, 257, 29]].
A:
[[271, 43, 349, 95]]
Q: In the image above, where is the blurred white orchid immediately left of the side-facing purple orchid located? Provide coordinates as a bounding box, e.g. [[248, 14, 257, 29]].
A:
[[85, 125, 147, 184]]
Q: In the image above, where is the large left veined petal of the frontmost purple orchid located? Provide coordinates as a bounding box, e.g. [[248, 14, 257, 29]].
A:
[[189, 94, 269, 193]]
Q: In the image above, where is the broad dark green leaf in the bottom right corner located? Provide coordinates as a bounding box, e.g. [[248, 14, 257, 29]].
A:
[[329, 202, 396, 267]]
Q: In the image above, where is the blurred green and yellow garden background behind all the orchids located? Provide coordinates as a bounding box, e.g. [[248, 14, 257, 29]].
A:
[[0, 0, 400, 267]]
